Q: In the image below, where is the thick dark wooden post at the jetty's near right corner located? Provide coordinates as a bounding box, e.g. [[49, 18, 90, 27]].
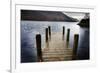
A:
[[72, 34, 79, 60]]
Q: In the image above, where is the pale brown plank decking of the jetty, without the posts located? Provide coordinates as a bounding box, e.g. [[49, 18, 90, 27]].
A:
[[42, 32, 73, 61]]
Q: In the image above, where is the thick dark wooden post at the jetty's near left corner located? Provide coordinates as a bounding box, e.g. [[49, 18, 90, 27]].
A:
[[36, 34, 43, 62]]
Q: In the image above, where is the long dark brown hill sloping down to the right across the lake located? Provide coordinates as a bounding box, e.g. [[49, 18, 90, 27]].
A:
[[21, 10, 78, 22]]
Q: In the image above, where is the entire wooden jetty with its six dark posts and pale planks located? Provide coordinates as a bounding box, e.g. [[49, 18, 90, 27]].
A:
[[36, 26, 79, 62]]
